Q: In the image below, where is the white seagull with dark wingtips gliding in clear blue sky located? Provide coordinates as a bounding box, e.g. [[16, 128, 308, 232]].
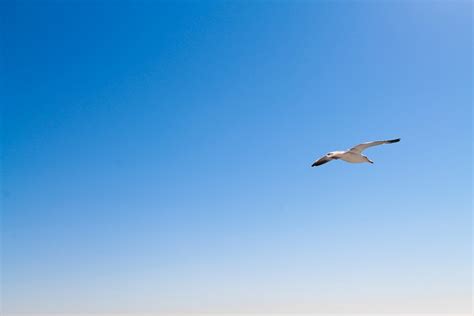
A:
[[311, 138, 400, 167]]
